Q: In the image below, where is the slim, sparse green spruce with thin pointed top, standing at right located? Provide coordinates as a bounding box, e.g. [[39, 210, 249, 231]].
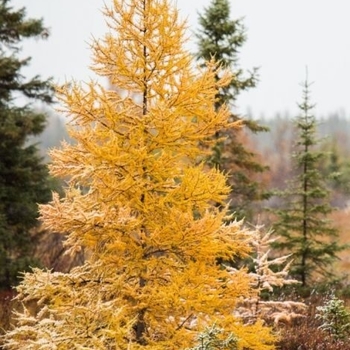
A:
[[273, 80, 345, 287]]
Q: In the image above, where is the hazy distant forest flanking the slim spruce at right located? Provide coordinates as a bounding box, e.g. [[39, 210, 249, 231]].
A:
[[248, 113, 350, 209]]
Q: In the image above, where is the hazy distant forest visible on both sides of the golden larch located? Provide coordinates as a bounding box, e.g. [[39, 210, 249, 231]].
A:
[[31, 110, 350, 208]]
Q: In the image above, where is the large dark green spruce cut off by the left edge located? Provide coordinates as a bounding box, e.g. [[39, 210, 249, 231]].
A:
[[0, 0, 53, 289]]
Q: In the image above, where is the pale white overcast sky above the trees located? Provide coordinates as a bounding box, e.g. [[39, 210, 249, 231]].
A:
[[11, 0, 350, 118]]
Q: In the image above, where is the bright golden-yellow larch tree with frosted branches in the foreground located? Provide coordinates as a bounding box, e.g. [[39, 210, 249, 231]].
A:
[[5, 0, 274, 350]]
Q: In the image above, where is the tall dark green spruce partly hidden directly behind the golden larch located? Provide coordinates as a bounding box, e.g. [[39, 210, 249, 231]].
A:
[[196, 0, 267, 219]]
